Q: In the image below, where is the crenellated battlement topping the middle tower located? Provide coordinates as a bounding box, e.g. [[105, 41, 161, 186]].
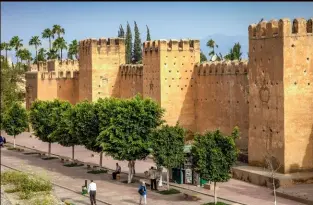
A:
[[143, 39, 200, 52]]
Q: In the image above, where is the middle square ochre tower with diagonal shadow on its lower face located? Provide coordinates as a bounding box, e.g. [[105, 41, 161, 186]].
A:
[[143, 39, 200, 131]]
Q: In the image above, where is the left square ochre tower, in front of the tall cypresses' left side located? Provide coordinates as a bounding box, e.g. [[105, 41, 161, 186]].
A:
[[79, 38, 125, 101]]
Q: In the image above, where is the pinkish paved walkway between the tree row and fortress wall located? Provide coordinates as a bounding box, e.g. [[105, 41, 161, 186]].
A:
[[3, 132, 300, 205]]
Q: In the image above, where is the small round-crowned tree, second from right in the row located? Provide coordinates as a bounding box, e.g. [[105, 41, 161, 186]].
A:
[[151, 123, 186, 190]]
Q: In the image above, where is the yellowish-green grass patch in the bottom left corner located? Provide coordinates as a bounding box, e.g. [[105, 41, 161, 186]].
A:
[[1, 171, 52, 199]]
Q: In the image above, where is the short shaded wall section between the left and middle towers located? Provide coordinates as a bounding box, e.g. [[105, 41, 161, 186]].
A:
[[119, 64, 143, 98]]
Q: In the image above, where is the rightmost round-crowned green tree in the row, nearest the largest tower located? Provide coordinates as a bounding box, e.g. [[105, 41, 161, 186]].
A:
[[191, 127, 239, 204]]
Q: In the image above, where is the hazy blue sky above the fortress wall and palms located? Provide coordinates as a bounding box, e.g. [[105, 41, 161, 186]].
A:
[[1, 2, 313, 59]]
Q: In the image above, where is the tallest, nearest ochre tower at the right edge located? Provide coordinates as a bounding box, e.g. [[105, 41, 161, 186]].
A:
[[248, 18, 313, 173]]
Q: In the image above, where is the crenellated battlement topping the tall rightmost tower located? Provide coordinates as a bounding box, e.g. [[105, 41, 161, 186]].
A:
[[248, 18, 313, 39]]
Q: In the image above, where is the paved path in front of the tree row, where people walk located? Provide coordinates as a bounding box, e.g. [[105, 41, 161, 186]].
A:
[[1, 149, 222, 205]]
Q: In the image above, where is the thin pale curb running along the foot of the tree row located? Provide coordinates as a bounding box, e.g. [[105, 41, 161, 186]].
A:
[[7, 141, 248, 205]]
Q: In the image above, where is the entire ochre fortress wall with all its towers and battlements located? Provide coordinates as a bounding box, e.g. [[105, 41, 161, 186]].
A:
[[26, 18, 313, 173]]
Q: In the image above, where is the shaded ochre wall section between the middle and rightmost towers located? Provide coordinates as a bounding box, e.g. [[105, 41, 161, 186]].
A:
[[195, 61, 249, 149]]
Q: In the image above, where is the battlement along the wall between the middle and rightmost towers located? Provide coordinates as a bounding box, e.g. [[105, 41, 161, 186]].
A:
[[195, 60, 248, 76]]
